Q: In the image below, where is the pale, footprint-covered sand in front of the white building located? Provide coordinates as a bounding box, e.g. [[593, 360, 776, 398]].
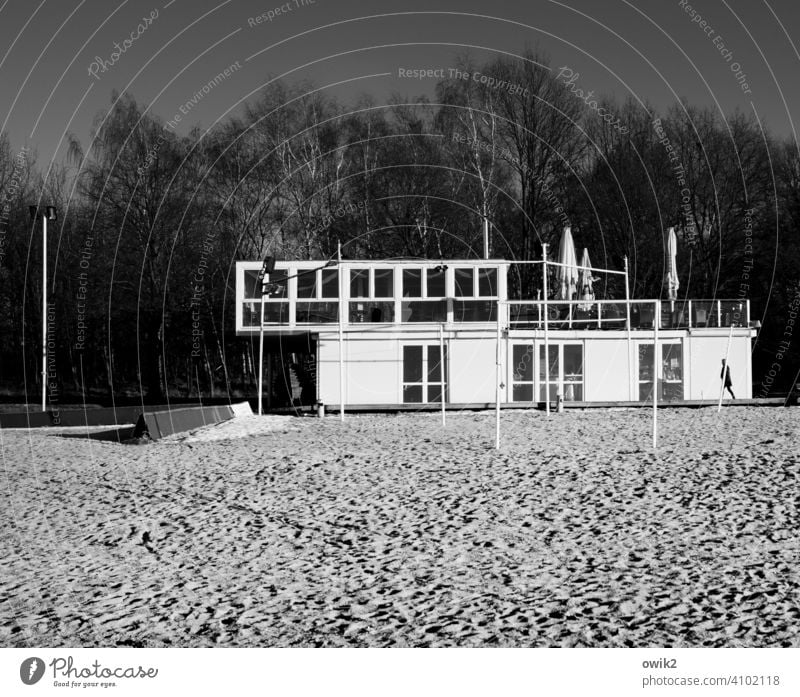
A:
[[0, 407, 800, 647]]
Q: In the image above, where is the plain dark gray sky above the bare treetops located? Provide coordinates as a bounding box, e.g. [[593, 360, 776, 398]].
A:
[[0, 0, 800, 165]]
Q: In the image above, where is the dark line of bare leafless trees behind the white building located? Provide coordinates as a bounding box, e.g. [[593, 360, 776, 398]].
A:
[[0, 52, 800, 400]]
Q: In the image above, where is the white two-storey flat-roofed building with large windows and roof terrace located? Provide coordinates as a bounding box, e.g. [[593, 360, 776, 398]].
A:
[[236, 259, 756, 410]]
